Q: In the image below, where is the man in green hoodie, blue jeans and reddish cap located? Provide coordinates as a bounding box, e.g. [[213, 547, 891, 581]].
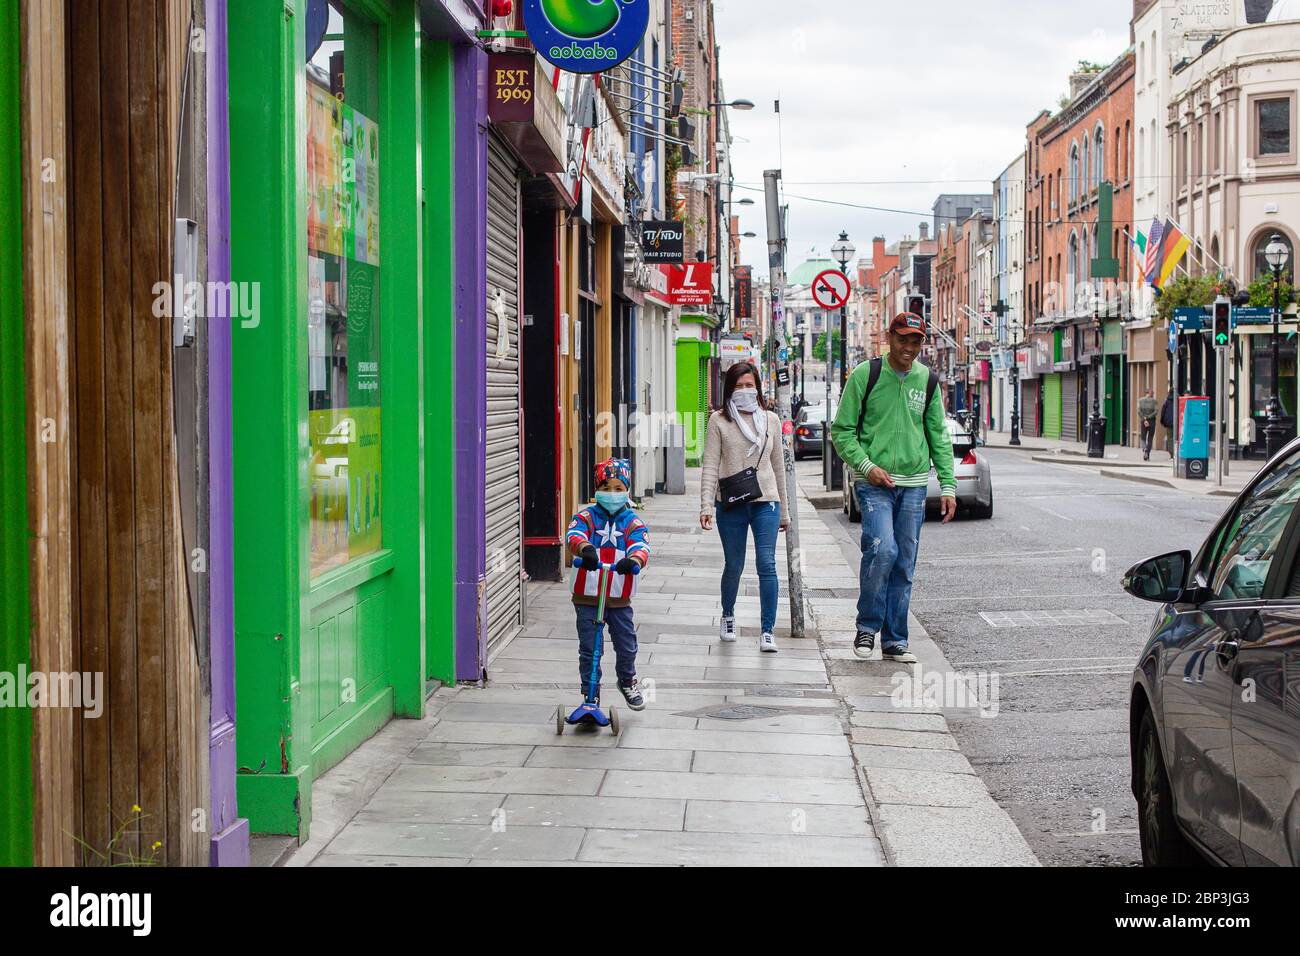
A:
[[831, 312, 957, 663]]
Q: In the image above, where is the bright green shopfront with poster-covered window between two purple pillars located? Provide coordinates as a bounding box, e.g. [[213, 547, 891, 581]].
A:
[[230, 0, 455, 839]]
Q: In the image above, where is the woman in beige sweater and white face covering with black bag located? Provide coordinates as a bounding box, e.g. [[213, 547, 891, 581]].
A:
[[699, 362, 789, 654]]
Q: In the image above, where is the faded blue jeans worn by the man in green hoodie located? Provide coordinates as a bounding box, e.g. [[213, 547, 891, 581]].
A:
[[853, 481, 926, 650]]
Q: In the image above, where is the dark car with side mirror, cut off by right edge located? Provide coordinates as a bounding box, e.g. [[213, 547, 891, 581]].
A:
[[1123, 441, 1300, 866]]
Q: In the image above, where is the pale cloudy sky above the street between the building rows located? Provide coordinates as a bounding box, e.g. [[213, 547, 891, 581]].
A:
[[715, 0, 1132, 273]]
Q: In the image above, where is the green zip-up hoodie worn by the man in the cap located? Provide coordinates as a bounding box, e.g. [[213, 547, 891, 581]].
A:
[[831, 358, 957, 497]]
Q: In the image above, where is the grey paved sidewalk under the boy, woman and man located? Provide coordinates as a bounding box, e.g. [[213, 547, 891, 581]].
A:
[[289, 470, 1034, 866]]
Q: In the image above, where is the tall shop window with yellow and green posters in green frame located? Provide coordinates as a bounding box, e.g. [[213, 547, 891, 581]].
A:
[[304, 3, 384, 576]]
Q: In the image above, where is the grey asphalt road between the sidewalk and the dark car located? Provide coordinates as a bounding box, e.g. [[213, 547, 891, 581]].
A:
[[800, 449, 1231, 866]]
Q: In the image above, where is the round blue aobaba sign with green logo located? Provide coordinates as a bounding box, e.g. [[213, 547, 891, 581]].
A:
[[524, 0, 650, 73]]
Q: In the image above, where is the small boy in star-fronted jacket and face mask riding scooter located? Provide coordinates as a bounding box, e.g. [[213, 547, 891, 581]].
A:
[[566, 458, 650, 710]]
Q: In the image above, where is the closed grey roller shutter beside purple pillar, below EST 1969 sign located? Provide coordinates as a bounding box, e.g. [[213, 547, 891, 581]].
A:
[[485, 134, 523, 661]]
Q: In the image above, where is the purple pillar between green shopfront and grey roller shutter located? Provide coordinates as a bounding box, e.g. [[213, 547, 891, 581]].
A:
[[452, 47, 488, 680]]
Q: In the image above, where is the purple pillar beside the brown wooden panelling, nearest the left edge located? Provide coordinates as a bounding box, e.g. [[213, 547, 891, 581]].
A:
[[207, 0, 248, 866]]
